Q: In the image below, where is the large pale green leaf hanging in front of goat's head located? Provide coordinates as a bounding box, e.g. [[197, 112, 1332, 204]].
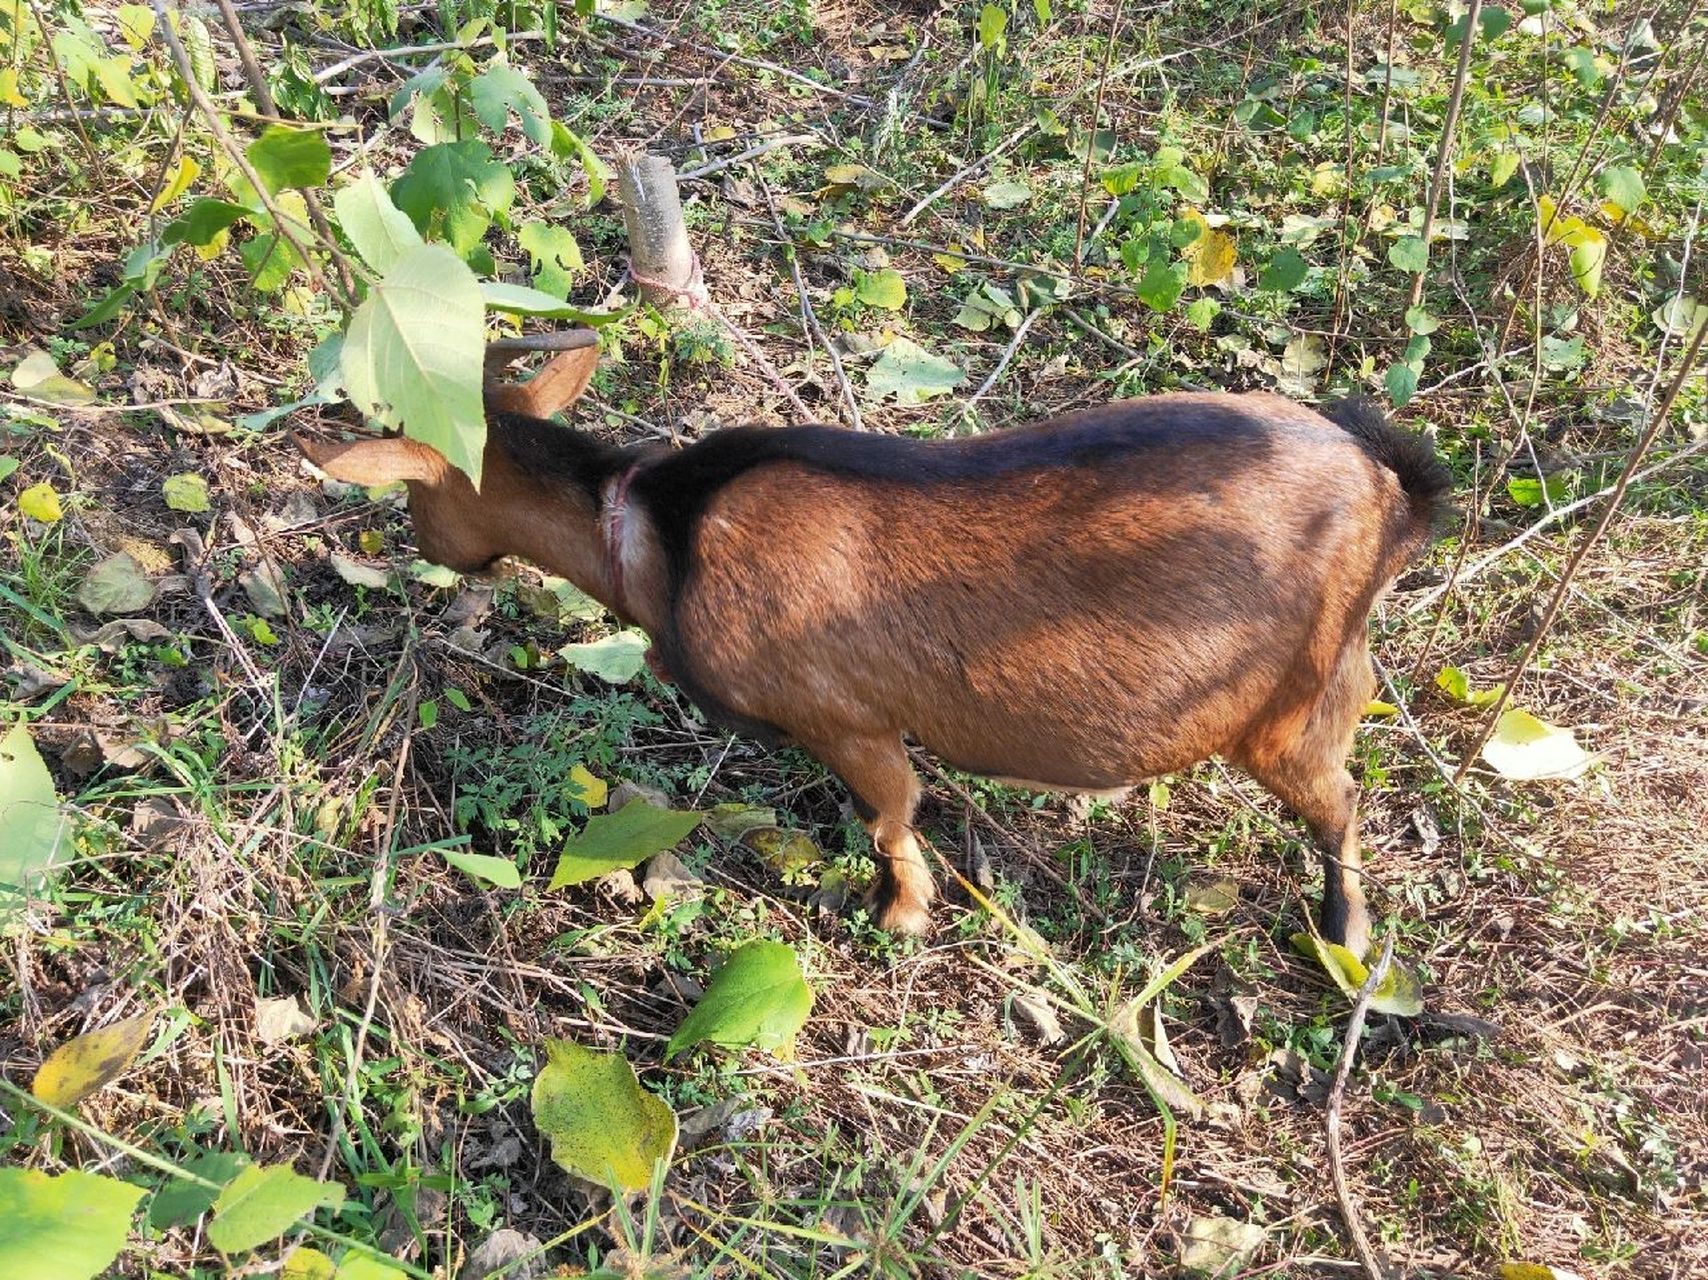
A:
[[338, 244, 487, 485]]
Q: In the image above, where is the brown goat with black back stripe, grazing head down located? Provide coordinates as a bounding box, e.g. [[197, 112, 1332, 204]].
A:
[[299, 349, 1450, 954]]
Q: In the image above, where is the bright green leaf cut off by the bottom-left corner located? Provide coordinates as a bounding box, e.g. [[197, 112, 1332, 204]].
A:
[[0, 1169, 145, 1280]]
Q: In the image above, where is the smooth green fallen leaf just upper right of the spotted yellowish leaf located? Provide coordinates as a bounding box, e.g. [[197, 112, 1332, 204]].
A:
[[664, 938, 813, 1061]]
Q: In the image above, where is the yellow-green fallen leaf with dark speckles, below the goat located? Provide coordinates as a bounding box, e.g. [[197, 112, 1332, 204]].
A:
[[531, 1039, 676, 1193]]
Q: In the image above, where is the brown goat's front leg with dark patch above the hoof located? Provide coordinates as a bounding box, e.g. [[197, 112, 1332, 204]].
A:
[[810, 737, 938, 937]]
